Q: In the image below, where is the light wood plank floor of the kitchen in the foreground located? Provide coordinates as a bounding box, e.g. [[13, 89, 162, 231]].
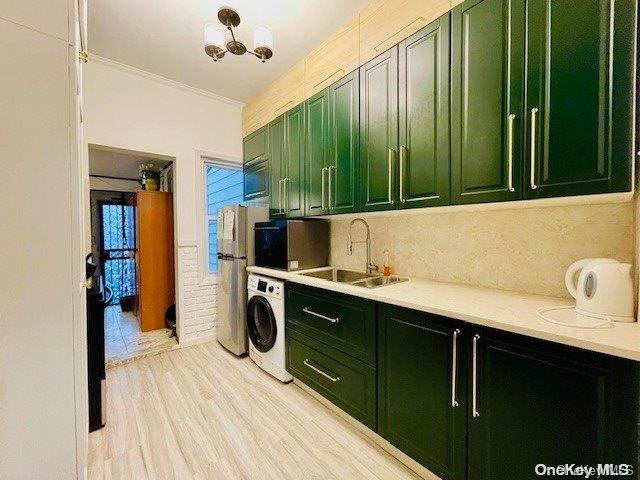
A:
[[89, 342, 419, 480]]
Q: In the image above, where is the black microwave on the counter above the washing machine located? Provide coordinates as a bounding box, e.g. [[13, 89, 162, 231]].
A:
[[253, 220, 329, 271]]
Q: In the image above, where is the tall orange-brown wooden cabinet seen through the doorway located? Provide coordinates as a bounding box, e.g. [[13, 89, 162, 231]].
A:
[[135, 191, 175, 332]]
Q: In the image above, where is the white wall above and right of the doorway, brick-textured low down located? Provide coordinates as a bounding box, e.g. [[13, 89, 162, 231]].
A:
[[84, 56, 242, 343]]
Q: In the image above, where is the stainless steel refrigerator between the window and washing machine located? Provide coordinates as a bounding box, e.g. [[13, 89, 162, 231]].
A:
[[216, 205, 269, 355]]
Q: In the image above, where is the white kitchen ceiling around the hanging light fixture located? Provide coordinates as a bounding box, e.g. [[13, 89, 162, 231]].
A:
[[88, 0, 369, 102]]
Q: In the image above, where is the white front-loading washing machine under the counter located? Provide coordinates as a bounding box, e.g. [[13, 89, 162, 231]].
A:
[[247, 275, 293, 382]]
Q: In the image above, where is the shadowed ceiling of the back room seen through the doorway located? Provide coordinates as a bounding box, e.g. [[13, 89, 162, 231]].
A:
[[89, 145, 172, 180]]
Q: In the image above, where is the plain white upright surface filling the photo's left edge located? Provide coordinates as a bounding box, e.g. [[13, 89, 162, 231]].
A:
[[0, 0, 86, 480]]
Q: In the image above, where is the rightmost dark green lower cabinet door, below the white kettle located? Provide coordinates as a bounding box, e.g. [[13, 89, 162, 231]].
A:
[[468, 330, 638, 480]]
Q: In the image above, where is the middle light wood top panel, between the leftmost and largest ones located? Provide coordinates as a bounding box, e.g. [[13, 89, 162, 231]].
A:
[[305, 18, 360, 98]]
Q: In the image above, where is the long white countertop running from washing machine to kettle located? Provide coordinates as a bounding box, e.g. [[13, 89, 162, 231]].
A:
[[247, 267, 640, 361]]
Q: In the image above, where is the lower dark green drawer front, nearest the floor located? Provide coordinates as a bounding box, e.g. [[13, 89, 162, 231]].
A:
[[287, 330, 376, 430]]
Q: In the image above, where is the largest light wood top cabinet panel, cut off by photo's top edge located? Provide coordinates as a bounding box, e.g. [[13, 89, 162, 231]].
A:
[[360, 0, 451, 65]]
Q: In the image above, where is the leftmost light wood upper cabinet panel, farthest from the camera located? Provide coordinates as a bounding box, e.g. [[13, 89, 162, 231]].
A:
[[242, 60, 305, 136]]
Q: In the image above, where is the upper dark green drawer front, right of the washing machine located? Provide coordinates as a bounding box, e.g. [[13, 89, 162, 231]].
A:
[[285, 285, 376, 365]]
